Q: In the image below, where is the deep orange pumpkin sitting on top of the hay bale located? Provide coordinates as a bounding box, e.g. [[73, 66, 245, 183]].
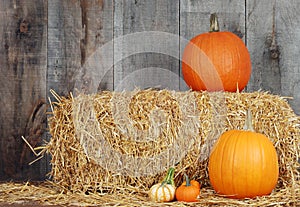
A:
[[182, 14, 251, 92]]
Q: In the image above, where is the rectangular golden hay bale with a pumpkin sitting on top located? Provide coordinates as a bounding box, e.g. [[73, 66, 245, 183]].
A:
[[46, 89, 300, 199]]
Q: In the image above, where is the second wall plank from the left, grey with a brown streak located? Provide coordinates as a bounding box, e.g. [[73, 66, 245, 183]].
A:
[[47, 0, 113, 97]]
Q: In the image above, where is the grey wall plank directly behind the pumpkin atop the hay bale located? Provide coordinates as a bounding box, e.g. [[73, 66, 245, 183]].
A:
[[180, 0, 246, 90]]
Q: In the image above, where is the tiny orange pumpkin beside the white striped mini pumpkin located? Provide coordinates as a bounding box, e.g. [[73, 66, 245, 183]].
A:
[[175, 174, 200, 202]]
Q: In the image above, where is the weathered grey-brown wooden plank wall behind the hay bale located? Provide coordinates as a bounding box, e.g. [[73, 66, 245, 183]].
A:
[[0, 0, 300, 180]]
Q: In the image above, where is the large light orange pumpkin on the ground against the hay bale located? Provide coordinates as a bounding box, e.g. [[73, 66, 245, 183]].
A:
[[208, 110, 279, 198]]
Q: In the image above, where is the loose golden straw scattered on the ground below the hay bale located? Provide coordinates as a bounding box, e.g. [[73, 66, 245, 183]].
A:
[[0, 182, 300, 207]]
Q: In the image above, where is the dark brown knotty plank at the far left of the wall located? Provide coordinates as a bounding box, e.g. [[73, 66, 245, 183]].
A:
[[0, 0, 47, 180]]
